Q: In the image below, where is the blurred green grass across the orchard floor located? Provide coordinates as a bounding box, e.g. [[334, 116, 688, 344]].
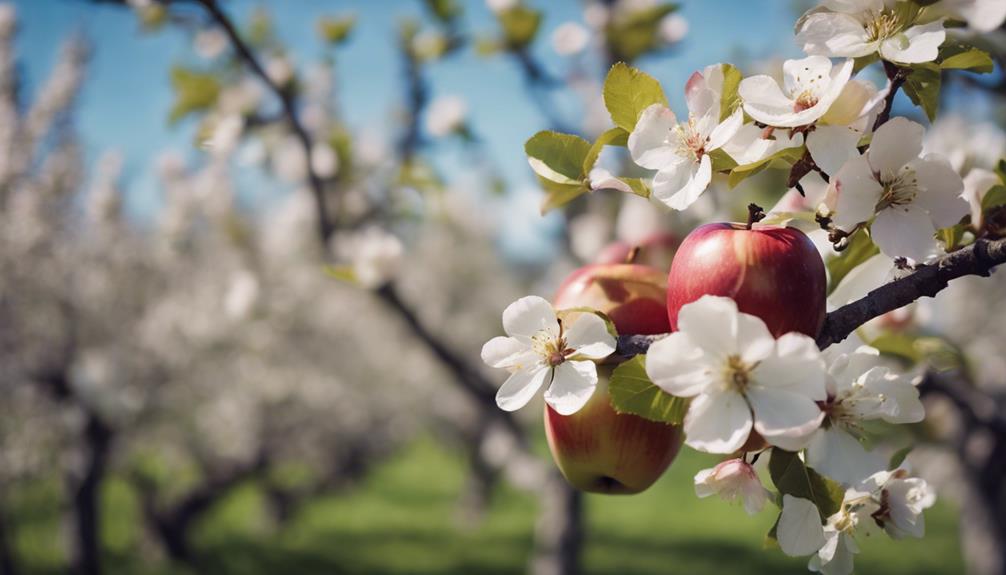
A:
[[7, 440, 963, 575]]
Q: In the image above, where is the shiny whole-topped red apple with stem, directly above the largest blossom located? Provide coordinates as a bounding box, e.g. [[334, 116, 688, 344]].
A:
[[667, 223, 827, 338]]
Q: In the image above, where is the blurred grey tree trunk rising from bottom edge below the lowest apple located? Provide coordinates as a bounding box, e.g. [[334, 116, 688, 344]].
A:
[[531, 471, 583, 575]]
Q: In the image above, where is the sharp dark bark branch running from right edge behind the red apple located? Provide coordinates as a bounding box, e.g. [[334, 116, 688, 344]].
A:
[[615, 238, 1006, 358]]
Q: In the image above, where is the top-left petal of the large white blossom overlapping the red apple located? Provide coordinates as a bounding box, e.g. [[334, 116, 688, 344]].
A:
[[678, 296, 740, 363]]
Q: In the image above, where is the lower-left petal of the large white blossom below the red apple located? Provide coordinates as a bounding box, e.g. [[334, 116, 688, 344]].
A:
[[684, 391, 751, 453]]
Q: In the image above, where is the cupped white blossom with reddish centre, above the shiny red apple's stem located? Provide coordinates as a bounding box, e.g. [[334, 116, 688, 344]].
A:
[[738, 56, 853, 128]]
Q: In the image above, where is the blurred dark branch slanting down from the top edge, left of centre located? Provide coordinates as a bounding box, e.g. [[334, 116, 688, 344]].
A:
[[196, 0, 335, 243]]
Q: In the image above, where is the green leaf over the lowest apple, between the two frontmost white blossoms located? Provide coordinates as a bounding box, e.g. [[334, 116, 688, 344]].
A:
[[608, 355, 688, 425]]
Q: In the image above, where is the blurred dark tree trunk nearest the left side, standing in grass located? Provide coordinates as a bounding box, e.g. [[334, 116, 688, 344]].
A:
[[70, 414, 113, 575]]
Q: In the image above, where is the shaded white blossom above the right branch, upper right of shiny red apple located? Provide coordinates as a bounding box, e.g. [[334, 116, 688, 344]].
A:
[[832, 118, 969, 261]]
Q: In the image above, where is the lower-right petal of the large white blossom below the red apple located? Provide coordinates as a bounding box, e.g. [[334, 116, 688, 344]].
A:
[[747, 386, 824, 445]]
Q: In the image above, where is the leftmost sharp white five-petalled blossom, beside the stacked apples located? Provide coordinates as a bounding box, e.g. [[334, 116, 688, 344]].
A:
[[482, 296, 615, 415]]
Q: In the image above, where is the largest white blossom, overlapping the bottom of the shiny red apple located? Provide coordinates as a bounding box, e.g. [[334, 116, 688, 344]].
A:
[[646, 296, 827, 453]]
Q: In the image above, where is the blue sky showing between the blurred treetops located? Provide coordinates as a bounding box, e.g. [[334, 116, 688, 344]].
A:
[[14, 0, 796, 218]]
